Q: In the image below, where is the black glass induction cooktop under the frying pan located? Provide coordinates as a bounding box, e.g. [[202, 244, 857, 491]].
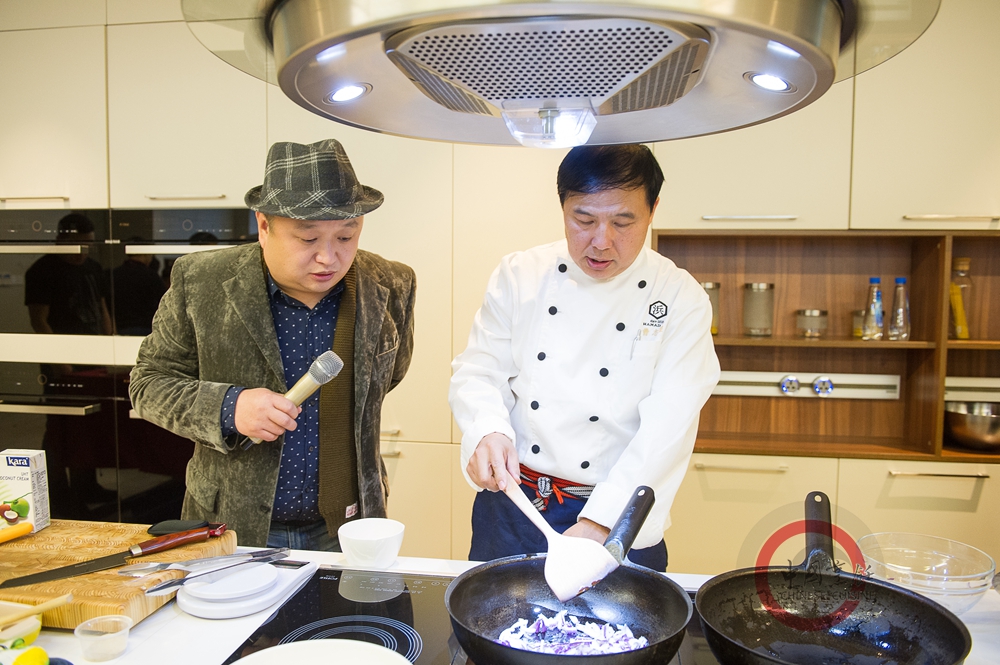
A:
[[225, 567, 718, 665]]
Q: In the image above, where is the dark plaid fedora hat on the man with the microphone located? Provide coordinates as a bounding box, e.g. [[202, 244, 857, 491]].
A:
[[244, 139, 384, 219]]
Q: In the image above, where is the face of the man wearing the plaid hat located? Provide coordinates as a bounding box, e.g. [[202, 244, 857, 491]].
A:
[[257, 212, 364, 307]]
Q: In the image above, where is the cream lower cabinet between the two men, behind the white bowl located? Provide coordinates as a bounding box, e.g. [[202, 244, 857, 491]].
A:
[[382, 440, 454, 559]]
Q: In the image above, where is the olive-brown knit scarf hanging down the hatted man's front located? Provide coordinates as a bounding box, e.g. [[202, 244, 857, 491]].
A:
[[319, 266, 360, 536]]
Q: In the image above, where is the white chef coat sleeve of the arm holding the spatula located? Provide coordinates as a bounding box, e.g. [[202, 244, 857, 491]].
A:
[[448, 257, 517, 491]]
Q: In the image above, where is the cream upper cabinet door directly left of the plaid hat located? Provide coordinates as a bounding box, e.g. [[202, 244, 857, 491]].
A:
[[107, 22, 266, 208]]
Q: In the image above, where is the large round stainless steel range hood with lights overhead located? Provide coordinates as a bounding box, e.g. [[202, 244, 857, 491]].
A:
[[181, 0, 940, 147]]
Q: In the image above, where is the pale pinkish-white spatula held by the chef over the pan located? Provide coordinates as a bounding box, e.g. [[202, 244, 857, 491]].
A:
[[504, 471, 619, 603]]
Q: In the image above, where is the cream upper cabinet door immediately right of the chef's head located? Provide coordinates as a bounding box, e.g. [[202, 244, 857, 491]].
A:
[[653, 81, 853, 230]]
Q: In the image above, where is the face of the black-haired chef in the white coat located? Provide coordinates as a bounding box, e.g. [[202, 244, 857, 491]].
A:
[[563, 188, 660, 279]]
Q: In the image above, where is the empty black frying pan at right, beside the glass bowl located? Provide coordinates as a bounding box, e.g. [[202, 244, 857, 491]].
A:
[[695, 492, 972, 665]]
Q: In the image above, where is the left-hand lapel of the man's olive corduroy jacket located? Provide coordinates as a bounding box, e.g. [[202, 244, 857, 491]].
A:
[[222, 243, 287, 391]]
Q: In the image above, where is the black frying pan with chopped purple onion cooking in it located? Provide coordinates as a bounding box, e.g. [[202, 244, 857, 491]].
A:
[[444, 492, 693, 665]]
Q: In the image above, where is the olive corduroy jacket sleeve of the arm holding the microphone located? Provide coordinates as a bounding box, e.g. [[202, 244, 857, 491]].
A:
[[129, 261, 239, 453]]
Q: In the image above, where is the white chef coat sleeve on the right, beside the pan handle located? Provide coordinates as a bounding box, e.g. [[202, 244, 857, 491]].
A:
[[580, 278, 720, 549]]
